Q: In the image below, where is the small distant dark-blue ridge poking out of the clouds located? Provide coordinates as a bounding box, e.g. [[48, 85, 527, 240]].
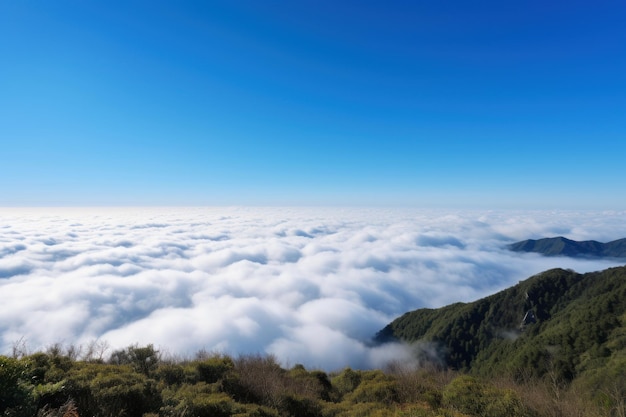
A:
[[509, 236, 626, 258]]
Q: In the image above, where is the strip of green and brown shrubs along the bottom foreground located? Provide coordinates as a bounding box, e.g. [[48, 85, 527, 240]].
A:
[[0, 346, 624, 417]]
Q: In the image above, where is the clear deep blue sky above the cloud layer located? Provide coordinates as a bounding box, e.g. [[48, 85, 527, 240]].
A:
[[0, 0, 626, 209]]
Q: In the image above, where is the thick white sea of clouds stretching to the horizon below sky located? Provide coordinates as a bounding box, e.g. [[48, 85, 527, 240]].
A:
[[0, 208, 626, 370]]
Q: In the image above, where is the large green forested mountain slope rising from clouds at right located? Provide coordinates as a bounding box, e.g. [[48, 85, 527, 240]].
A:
[[377, 267, 626, 383]]
